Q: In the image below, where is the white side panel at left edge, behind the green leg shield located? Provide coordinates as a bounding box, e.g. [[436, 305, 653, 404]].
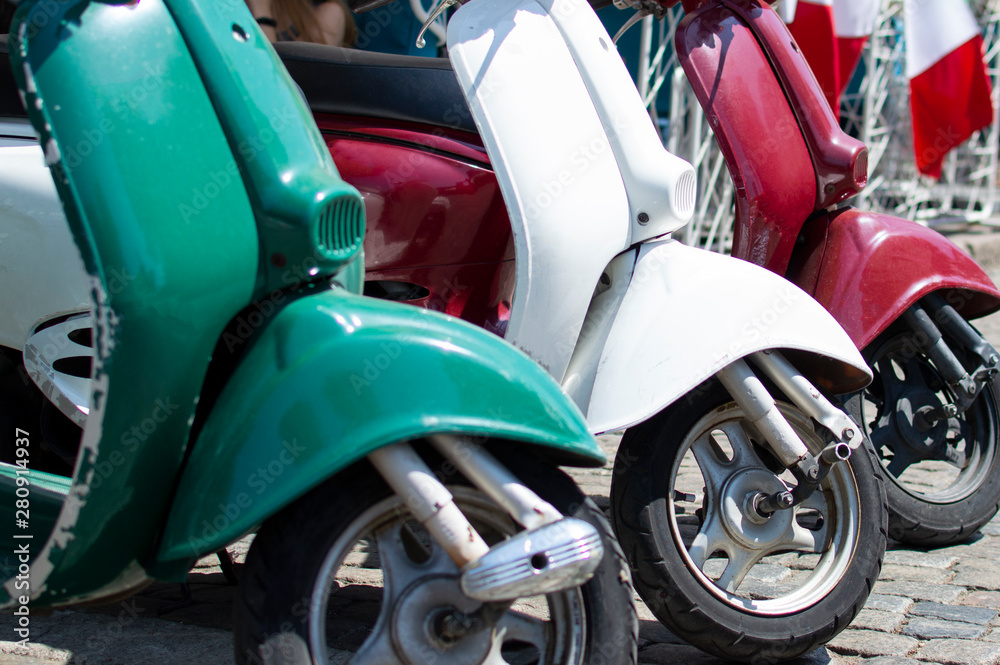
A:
[[0, 127, 90, 350]]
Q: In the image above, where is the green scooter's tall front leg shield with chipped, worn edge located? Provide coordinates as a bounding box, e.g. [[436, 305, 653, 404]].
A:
[[0, 0, 258, 605]]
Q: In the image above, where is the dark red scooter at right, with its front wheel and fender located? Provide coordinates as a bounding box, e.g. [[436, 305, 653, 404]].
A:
[[666, 0, 1000, 545]]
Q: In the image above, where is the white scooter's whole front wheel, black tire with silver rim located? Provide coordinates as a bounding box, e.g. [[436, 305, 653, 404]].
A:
[[611, 381, 886, 662]]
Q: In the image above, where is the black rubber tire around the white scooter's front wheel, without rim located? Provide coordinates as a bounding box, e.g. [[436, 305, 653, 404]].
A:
[[611, 384, 887, 664]]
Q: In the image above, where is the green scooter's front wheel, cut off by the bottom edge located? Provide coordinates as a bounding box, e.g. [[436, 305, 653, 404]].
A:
[[234, 452, 637, 665]]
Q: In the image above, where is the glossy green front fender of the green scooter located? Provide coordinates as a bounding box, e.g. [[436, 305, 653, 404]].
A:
[[153, 290, 604, 578]]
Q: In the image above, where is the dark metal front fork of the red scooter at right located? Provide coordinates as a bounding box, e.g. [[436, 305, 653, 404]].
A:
[[903, 293, 1000, 430]]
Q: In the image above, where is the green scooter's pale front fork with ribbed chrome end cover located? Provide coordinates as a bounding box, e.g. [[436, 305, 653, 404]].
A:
[[368, 435, 604, 604]]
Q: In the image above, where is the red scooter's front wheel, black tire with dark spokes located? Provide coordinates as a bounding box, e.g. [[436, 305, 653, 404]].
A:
[[847, 329, 1000, 547]]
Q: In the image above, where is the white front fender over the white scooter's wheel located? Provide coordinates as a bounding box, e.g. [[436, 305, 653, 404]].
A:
[[581, 240, 872, 432]]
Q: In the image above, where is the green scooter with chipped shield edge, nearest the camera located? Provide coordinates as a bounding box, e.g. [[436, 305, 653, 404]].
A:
[[0, 0, 637, 665]]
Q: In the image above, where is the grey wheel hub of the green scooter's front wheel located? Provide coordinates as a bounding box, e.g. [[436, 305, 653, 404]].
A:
[[391, 575, 495, 665]]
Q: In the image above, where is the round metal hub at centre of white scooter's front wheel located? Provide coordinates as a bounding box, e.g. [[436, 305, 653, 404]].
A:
[[722, 468, 795, 550]]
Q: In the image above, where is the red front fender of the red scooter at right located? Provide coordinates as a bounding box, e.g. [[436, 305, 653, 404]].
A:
[[787, 208, 1000, 349]]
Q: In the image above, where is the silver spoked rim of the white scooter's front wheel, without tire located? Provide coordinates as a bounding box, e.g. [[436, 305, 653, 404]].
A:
[[667, 396, 860, 616]]
